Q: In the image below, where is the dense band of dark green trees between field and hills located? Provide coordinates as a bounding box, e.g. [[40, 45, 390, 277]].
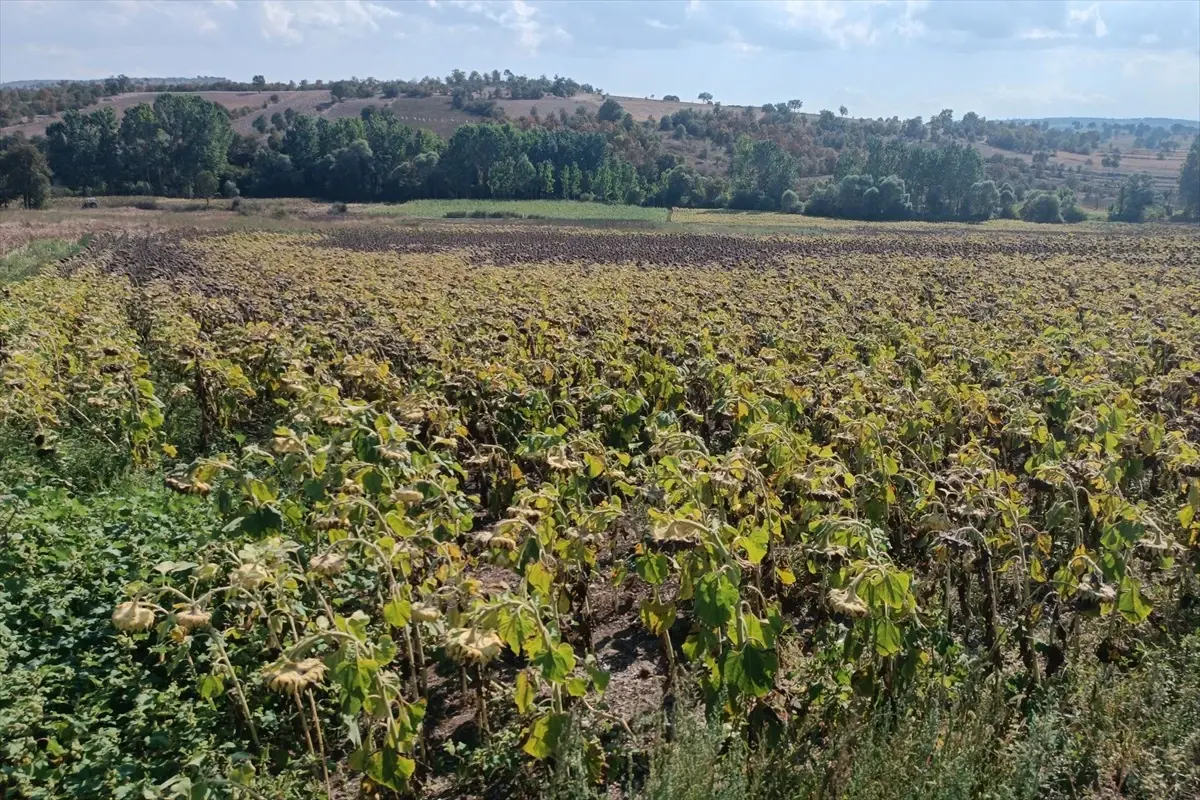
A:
[[0, 89, 1195, 222]]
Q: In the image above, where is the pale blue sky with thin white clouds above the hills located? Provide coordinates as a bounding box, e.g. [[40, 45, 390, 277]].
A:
[[0, 0, 1200, 120]]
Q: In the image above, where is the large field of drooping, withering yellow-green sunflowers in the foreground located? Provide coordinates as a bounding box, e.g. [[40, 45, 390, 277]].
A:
[[0, 214, 1200, 800]]
